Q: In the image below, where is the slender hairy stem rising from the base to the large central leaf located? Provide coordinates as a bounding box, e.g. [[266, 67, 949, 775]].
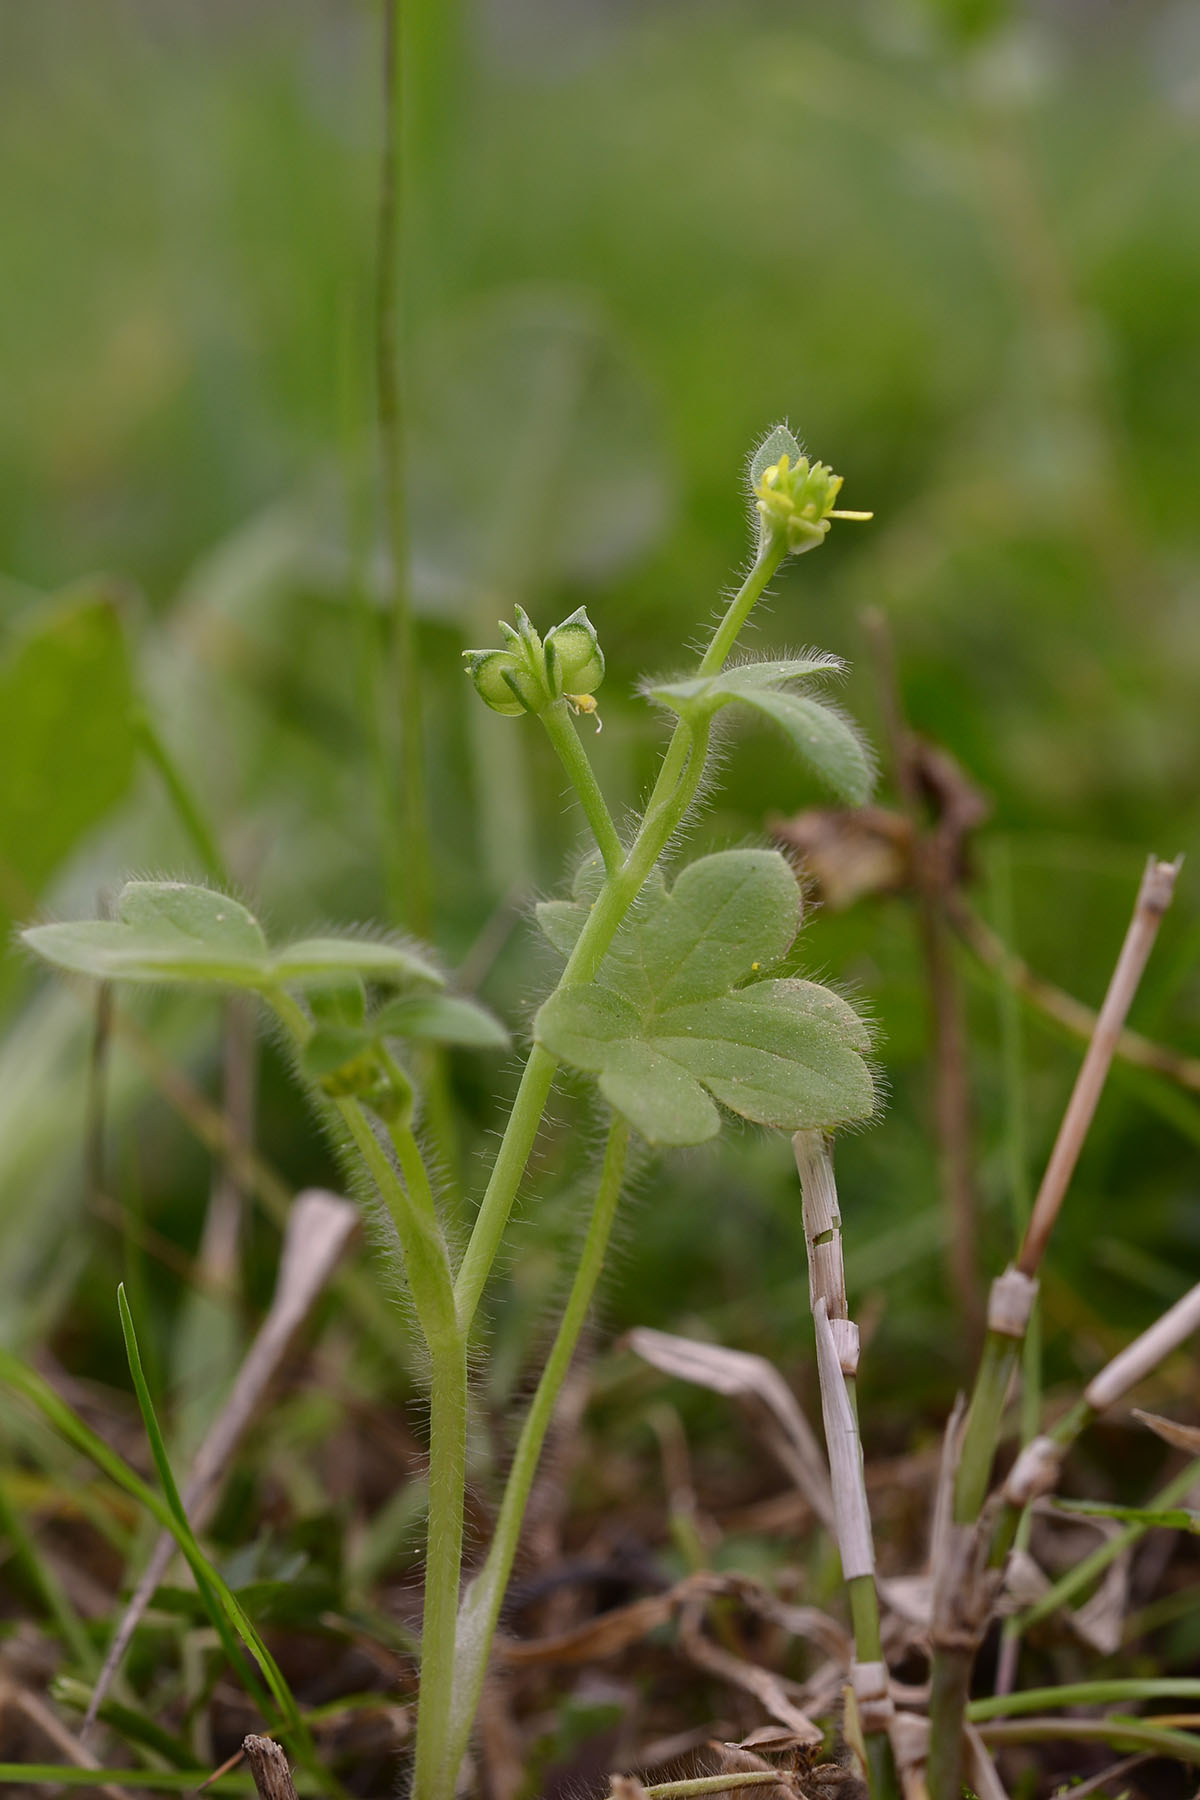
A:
[[438, 1116, 630, 1800]]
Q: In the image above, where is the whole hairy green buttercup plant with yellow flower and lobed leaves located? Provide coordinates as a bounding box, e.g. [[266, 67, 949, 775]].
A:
[[25, 427, 876, 1800]]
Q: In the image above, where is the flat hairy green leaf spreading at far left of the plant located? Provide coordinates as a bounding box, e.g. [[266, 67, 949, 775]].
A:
[[22, 882, 443, 990]]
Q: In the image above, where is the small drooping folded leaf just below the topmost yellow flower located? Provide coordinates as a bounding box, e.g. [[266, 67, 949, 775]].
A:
[[646, 652, 873, 806]]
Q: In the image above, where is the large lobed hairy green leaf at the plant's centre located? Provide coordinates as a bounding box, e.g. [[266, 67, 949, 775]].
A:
[[534, 850, 874, 1145]]
